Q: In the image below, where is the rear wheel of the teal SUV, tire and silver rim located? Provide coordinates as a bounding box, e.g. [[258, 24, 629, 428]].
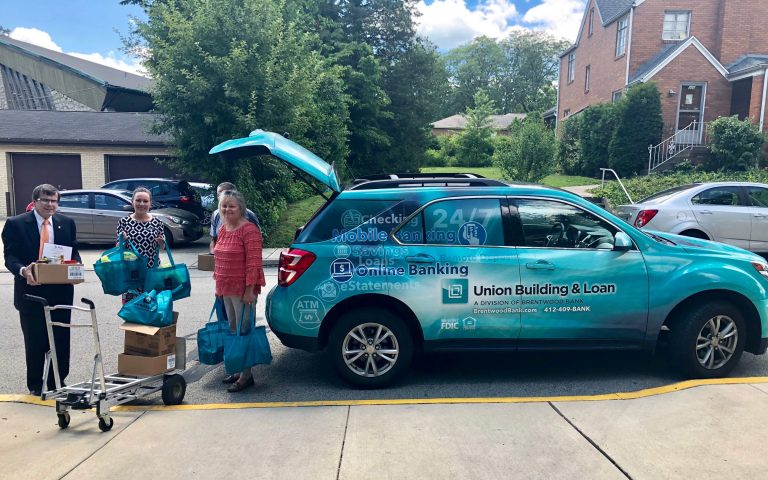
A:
[[328, 307, 413, 389]]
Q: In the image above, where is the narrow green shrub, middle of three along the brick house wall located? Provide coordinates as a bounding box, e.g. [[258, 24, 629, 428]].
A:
[[578, 103, 616, 178]]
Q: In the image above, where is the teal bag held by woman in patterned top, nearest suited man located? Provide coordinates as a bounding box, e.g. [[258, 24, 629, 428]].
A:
[[93, 240, 147, 295]]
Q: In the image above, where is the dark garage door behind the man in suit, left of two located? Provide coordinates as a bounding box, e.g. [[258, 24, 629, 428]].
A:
[[8, 153, 83, 215]]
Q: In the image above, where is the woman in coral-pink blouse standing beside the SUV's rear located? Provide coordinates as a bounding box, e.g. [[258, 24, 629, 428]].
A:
[[213, 190, 267, 392]]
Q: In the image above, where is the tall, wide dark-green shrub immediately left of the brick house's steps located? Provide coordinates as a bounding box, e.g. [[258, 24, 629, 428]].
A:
[[609, 82, 664, 177]]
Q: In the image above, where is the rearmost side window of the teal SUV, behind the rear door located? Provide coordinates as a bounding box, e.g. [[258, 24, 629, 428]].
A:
[[296, 199, 398, 243]]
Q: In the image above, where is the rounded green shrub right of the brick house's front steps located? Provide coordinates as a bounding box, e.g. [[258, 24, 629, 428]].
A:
[[709, 115, 765, 170]]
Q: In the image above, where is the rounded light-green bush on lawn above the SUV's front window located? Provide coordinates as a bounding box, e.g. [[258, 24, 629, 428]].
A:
[[493, 116, 557, 182]]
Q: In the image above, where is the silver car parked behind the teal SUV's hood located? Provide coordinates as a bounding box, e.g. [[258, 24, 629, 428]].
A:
[[615, 182, 768, 252]]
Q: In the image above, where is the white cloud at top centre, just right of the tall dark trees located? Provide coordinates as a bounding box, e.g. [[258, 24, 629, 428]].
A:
[[416, 0, 519, 49]]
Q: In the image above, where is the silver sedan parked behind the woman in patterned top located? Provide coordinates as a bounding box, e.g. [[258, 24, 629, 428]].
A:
[[59, 189, 203, 244]]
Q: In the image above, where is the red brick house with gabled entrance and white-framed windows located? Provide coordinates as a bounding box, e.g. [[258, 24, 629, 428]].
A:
[[557, 0, 768, 146]]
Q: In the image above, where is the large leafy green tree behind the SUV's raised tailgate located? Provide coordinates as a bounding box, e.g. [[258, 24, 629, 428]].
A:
[[126, 0, 348, 231]]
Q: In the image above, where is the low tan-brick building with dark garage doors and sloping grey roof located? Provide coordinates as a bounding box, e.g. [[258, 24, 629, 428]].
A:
[[0, 35, 174, 216]]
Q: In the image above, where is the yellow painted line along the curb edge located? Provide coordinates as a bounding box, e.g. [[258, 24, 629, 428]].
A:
[[0, 377, 768, 412]]
